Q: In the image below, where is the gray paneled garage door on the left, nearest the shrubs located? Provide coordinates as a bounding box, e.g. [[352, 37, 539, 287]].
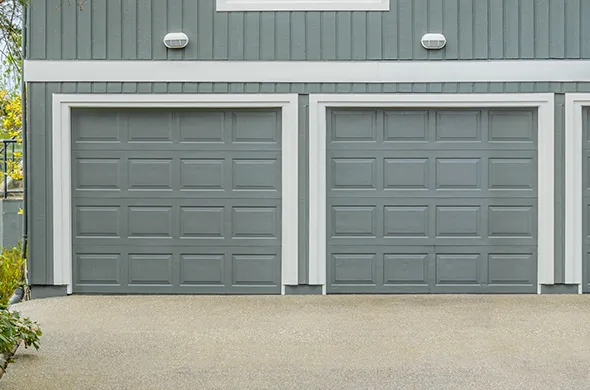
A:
[[72, 109, 281, 293]]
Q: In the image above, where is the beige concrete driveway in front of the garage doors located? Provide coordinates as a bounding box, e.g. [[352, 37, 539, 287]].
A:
[[0, 295, 590, 390]]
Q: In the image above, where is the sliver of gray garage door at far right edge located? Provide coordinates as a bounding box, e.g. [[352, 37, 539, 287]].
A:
[[582, 107, 590, 293]]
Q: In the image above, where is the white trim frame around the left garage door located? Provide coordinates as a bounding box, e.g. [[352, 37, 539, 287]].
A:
[[52, 94, 298, 294]]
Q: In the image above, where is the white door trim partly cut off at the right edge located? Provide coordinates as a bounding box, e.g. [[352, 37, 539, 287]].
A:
[[565, 93, 590, 293]]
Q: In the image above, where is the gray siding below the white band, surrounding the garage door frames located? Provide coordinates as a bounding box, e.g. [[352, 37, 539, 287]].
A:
[[27, 83, 590, 284]]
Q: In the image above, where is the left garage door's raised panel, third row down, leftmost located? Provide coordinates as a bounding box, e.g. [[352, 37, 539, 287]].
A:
[[76, 206, 121, 238]]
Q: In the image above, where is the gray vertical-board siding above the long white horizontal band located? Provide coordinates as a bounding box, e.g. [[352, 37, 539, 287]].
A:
[[28, 0, 590, 61]]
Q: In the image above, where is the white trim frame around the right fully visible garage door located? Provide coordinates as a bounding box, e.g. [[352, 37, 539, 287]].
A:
[[309, 93, 555, 294]]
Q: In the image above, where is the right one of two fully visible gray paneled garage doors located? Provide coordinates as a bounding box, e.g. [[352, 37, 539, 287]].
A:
[[327, 109, 537, 293]]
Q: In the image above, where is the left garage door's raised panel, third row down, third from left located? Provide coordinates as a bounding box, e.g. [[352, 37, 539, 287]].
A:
[[180, 207, 224, 238]]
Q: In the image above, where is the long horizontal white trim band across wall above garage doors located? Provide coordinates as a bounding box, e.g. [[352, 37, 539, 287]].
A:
[[24, 60, 590, 83]]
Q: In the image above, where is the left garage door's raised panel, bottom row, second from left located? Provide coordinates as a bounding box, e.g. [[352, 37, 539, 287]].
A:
[[129, 254, 172, 284]]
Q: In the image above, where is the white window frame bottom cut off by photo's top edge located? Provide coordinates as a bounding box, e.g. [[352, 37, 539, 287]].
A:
[[217, 0, 390, 11]]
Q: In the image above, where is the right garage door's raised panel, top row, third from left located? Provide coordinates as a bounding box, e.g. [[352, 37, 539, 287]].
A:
[[436, 110, 481, 142]]
